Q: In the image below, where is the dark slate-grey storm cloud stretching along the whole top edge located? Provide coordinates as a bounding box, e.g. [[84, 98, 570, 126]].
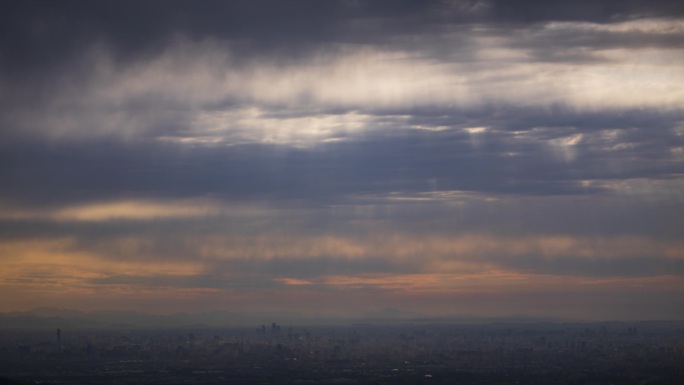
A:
[[5, 0, 684, 70]]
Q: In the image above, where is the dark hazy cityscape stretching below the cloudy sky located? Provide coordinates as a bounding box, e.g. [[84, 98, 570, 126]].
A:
[[0, 321, 684, 385]]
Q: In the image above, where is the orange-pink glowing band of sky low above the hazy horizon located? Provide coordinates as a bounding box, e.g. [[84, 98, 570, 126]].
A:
[[0, 228, 684, 314]]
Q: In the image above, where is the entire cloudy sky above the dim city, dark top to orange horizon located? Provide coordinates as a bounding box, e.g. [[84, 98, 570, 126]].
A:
[[0, 0, 684, 320]]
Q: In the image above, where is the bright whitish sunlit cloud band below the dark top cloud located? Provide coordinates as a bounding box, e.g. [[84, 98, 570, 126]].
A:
[[9, 19, 684, 145]]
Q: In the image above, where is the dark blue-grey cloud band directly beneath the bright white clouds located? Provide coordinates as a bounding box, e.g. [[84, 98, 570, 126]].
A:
[[0, 105, 684, 208]]
